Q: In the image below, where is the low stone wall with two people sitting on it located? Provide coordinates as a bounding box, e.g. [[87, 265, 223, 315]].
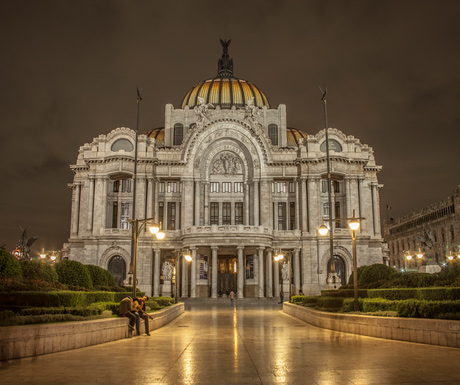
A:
[[0, 303, 184, 361]]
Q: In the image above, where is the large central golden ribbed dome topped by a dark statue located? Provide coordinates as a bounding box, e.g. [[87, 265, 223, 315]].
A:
[[181, 39, 270, 108]]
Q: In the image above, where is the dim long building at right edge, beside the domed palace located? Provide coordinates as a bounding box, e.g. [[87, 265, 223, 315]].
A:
[[384, 186, 460, 269]]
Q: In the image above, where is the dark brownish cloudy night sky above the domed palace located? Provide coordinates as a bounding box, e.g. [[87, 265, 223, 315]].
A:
[[0, 0, 460, 255]]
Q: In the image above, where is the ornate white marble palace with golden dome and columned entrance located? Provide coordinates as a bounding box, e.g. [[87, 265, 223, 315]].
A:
[[64, 40, 388, 299]]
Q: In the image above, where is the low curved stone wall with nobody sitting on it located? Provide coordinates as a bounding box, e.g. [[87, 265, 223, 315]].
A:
[[283, 303, 460, 348]]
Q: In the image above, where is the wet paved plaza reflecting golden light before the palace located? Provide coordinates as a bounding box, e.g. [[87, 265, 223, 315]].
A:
[[0, 301, 460, 385]]
